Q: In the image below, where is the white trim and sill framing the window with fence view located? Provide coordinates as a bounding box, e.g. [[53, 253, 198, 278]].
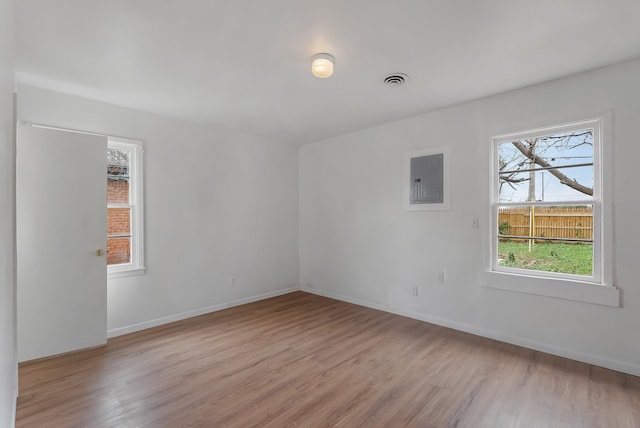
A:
[[481, 114, 620, 307]]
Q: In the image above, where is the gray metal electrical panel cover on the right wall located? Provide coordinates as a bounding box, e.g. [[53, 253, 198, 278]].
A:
[[409, 153, 444, 204]]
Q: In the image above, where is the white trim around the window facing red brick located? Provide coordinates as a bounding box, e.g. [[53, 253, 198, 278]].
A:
[[107, 137, 146, 279]]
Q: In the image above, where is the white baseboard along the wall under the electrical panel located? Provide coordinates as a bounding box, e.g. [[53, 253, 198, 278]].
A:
[[301, 287, 640, 376]]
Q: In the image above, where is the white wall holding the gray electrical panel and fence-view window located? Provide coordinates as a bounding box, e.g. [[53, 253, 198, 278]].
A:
[[300, 56, 640, 375]]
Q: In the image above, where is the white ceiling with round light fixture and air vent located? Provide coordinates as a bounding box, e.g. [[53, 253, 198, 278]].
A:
[[15, 0, 640, 143]]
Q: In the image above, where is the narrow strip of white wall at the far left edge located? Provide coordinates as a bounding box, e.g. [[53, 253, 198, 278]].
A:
[[0, 0, 18, 427]]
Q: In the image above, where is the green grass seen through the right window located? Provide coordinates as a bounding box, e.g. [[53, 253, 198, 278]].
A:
[[498, 242, 593, 275]]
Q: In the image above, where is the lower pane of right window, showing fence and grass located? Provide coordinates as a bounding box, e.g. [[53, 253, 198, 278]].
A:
[[497, 205, 593, 276]]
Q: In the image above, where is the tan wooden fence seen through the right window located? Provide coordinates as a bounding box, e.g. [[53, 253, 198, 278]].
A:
[[498, 206, 593, 242]]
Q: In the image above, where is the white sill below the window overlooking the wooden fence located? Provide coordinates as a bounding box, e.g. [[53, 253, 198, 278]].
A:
[[481, 271, 620, 308]]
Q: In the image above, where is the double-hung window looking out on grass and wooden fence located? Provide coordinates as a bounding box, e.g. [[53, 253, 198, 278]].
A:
[[491, 119, 603, 284]]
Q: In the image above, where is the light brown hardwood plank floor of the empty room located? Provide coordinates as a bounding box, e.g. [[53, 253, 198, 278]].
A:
[[17, 292, 640, 428]]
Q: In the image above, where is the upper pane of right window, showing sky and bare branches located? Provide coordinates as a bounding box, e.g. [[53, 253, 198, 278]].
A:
[[498, 129, 593, 202]]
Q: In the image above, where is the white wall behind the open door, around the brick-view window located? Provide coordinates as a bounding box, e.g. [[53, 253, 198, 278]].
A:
[[18, 85, 299, 336]]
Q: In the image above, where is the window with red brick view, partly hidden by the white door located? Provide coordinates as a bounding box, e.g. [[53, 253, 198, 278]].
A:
[[107, 137, 144, 278]]
